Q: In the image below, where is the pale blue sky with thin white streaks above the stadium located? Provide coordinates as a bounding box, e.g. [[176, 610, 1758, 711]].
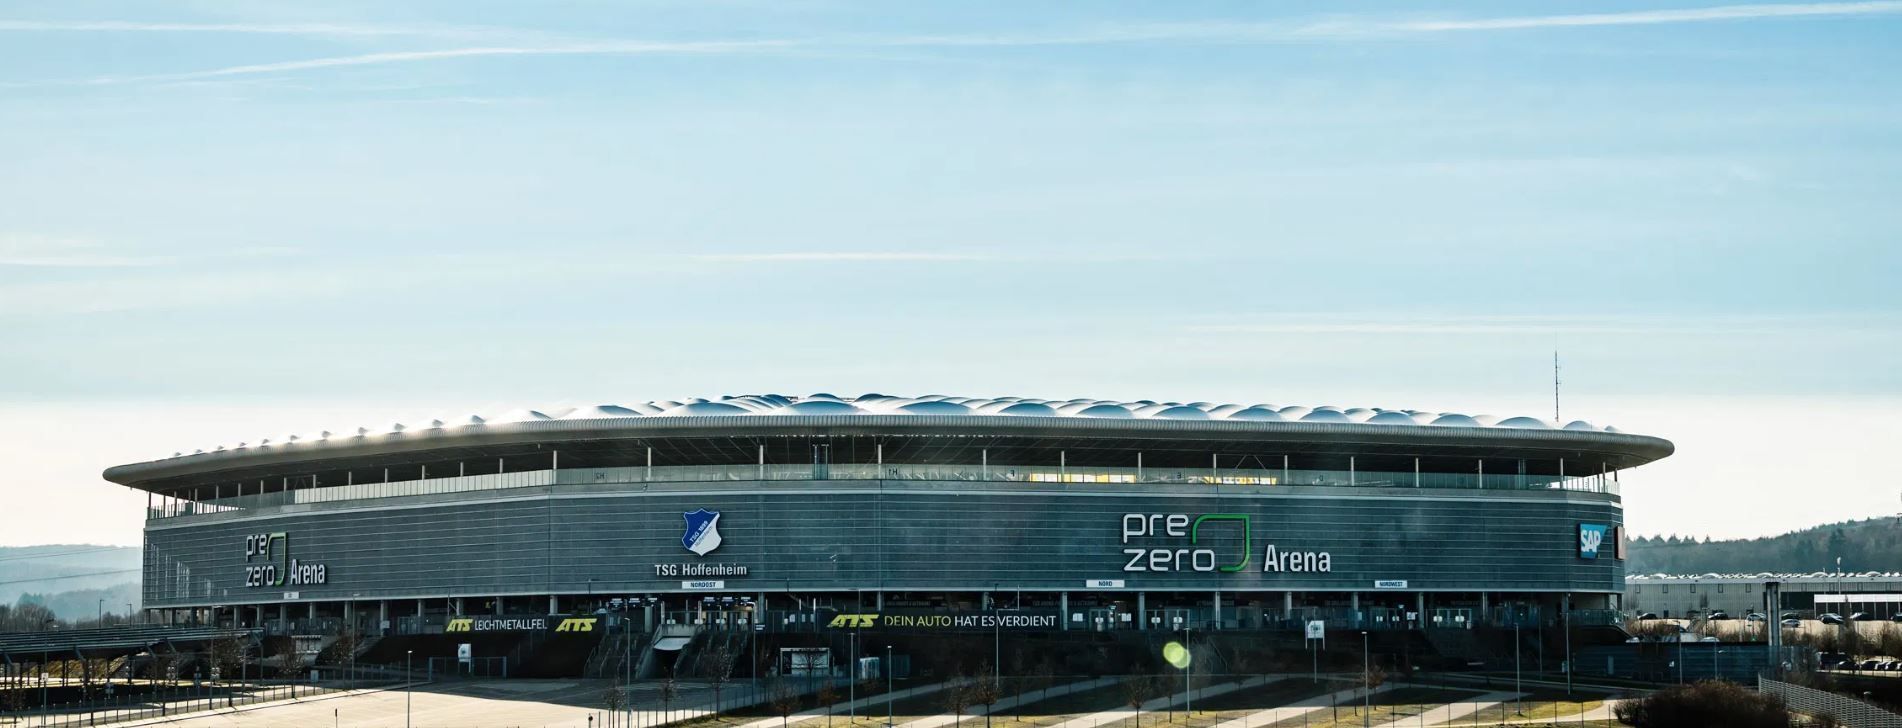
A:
[[0, 2, 1902, 542]]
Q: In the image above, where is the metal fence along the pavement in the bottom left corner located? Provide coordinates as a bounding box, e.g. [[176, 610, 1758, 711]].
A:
[[0, 682, 395, 728]]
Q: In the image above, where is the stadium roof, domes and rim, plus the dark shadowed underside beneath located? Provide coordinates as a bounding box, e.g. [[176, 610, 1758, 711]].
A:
[[105, 393, 1672, 492]]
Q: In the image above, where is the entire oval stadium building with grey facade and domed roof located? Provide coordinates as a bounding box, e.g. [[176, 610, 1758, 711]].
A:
[[105, 393, 1672, 633]]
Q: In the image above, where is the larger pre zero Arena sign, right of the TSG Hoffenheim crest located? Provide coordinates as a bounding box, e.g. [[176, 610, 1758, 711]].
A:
[[1122, 513, 1333, 572]]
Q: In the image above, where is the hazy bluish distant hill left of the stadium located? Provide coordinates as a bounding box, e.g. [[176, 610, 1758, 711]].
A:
[[0, 544, 141, 620]]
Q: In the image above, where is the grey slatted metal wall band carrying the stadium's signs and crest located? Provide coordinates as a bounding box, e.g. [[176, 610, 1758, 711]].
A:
[[145, 481, 1624, 606]]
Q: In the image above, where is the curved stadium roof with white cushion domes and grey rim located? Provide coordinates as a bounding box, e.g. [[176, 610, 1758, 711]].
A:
[[105, 393, 1672, 485]]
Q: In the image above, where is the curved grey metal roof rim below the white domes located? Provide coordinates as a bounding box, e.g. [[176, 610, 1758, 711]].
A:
[[103, 414, 1674, 487]]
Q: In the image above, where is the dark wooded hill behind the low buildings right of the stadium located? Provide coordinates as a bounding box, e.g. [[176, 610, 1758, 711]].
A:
[[1624, 517, 1902, 574]]
